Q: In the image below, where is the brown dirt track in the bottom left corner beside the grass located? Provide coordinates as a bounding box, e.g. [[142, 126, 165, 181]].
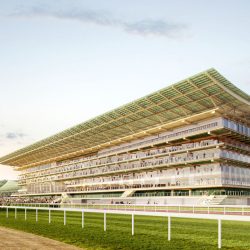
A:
[[0, 227, 81, 250]]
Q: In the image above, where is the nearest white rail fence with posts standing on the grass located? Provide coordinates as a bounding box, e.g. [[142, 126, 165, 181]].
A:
[[0, 206, 250, 248]]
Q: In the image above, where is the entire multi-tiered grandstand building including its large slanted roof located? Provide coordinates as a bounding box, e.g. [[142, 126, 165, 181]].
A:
[[0, 69, 250, 204]]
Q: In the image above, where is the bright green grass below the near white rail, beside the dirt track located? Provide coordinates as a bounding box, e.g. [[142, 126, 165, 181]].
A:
[[0, 209, 250, 250]]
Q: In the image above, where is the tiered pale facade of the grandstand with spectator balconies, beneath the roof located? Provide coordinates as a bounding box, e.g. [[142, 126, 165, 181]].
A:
[[19, 118, 250, 195]]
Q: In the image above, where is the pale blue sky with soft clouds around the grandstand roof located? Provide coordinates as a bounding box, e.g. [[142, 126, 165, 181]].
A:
[[0, 0, 250, 179]]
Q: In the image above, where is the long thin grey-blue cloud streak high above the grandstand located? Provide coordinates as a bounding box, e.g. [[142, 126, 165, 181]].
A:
[[11, 5, 188, 38]]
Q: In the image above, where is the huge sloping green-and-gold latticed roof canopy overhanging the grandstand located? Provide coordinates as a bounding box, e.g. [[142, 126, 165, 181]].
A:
[[0, 69, 250, 167]]
